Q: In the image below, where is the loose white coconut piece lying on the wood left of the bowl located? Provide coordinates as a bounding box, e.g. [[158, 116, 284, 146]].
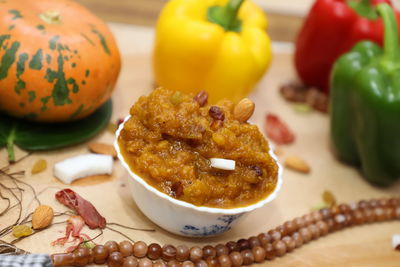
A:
[[53, 154, 113, 184]]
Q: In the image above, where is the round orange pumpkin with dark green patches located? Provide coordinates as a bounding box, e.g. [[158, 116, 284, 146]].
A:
[[0, 0, 121, 122]]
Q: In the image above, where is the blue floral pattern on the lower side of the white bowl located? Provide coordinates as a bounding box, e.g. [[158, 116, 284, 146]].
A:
[[180, 214, 243, 237]]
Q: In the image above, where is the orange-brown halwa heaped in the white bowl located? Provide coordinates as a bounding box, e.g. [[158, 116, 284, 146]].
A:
[[118, 89, 278, 208]]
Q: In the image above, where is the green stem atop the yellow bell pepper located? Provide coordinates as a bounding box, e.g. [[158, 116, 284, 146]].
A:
[[207, 0, 245, 32]]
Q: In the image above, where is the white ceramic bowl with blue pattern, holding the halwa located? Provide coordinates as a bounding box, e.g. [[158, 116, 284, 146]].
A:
[[114, 116, 282, 237]]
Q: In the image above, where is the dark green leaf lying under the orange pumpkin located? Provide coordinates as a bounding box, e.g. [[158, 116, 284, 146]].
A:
[[0, 100, 112, 161]]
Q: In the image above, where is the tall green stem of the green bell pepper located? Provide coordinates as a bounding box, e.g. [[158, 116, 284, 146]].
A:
[[377, 3, 400, 63]]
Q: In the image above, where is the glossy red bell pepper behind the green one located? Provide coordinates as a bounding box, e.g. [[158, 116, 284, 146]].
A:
[[295, 0, 400, 93]]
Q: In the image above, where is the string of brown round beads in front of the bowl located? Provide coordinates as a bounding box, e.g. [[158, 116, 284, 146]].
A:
[[51, 198, 400, 267]]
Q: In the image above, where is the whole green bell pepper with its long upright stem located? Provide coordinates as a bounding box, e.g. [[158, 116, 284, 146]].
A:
[[330, 3, 400, 186]]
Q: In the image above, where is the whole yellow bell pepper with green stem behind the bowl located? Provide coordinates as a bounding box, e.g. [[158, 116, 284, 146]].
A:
[[153, 0, 271, 103]]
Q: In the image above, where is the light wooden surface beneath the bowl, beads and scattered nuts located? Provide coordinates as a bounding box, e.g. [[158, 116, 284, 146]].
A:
[[0, 25, 400, 267]]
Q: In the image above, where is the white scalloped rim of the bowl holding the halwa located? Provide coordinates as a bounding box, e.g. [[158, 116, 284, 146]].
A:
[[114, 115, 283, 215]]
